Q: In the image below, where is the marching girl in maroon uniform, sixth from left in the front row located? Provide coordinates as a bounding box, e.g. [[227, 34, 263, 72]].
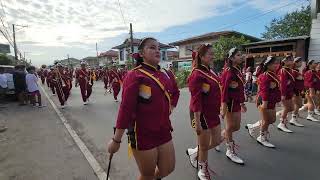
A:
[[289, 57, 304, 127]]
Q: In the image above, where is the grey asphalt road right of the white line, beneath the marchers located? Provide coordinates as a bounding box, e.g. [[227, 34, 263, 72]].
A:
[[43, 82, 320, 180]]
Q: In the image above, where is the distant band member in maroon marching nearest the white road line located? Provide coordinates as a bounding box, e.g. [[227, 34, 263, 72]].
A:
[[53, 63, 70, 109]]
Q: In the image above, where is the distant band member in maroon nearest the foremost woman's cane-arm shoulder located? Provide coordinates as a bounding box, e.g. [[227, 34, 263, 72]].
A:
[[109, 63, 122, 102]]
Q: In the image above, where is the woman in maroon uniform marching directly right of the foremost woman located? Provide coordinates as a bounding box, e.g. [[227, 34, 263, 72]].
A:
[[187, 45, 221, 180]]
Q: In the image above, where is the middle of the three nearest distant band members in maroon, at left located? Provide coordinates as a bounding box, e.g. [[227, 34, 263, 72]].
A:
[[76, 62, 93, 105]]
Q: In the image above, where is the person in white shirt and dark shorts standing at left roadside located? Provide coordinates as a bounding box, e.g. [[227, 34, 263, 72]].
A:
[[26, 66, 45, 108]]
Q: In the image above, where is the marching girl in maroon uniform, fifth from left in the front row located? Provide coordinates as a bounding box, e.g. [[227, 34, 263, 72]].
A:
[[277, 55, 295, 133]]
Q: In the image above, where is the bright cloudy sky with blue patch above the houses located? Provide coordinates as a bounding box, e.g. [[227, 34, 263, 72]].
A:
[[0, 0, 308, 66]]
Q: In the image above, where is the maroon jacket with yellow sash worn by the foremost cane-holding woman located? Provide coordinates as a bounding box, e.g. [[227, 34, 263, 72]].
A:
[[116, 63, 176, 150]]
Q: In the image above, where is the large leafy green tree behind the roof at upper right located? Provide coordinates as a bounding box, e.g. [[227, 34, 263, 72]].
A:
[[262, 5, 311, 39]]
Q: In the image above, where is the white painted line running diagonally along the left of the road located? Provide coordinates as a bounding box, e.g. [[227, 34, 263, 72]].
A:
[[40, 86, 110, 180]]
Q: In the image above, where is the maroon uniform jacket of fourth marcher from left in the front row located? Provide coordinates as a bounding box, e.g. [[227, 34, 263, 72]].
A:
[[257, 71, 281, 109]]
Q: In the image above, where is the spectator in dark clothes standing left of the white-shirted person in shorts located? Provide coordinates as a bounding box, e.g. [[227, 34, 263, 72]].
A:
[[13, 65, 27, 105]]
